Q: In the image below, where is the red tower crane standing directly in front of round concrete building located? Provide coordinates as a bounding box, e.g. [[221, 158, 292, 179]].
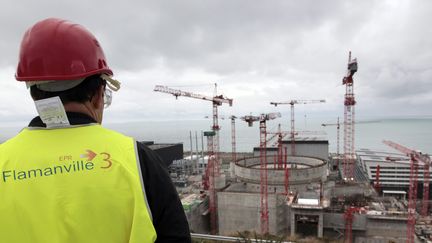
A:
[[240, 113, 281, 235]]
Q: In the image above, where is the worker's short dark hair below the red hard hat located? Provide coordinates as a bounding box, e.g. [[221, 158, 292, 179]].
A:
[[30, 75, 106, 104]]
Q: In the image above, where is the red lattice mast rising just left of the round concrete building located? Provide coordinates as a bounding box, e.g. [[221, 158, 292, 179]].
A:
[[204, 131, 217, 234]]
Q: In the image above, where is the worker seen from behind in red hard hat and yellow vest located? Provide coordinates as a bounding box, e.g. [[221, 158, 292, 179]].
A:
[[0, 18, 191, 243]]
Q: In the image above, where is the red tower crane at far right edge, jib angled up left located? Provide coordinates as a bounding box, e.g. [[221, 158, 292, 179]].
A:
[[383, 140, 431, 243]]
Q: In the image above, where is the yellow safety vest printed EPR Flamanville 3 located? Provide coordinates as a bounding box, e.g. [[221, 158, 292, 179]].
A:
[[0, 124, 156, 243]]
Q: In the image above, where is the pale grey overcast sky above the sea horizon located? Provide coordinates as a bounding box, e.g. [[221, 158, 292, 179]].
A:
[[0, 0, 432, 124]]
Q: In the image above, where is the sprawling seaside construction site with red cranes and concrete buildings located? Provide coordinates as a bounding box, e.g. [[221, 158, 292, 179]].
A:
[[154, 53, 432, 243]]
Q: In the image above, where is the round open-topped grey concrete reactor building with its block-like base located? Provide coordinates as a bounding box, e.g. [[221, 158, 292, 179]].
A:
[[217, 156, 327, 236]]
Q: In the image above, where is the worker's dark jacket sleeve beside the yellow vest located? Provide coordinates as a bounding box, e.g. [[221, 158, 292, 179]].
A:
[[137, 142, 191, 243]]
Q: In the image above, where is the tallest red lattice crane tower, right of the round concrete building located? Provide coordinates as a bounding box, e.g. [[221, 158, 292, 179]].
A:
[[342, 52, 358, 180]]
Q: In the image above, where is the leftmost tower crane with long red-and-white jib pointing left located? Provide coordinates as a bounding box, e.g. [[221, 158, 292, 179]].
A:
[[154, 84, 233, 175]]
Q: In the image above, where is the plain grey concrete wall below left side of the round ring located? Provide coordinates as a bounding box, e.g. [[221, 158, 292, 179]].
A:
[[217, 192, 284, 235]]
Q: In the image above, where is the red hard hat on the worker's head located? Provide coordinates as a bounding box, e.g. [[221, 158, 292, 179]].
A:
[[15, 18, 113, 81]]
